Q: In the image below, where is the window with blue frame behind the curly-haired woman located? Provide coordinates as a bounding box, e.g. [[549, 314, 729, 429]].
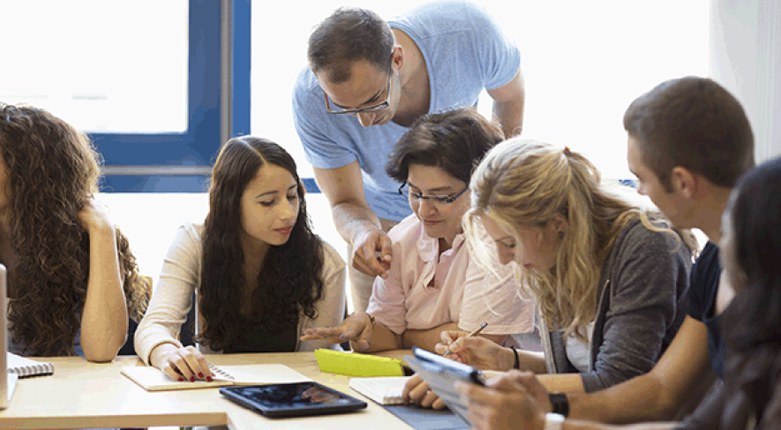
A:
[[0, 0, 249, 191]]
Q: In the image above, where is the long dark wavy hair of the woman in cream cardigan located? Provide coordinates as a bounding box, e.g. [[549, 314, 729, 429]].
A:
[[198, 136, 324, 350]]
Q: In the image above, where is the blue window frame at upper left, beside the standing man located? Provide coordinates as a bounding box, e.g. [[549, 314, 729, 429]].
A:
[[95, 0, 250, 192]]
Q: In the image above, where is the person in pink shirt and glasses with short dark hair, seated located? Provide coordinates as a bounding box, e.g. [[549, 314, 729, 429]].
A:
[[302, 108, 534, 351]]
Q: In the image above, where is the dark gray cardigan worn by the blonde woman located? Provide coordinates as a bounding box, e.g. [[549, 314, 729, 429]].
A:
[[542, 220, 692, 392]]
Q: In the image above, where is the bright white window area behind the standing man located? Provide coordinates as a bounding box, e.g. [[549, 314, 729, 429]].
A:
[[251, 0, 709, 178]]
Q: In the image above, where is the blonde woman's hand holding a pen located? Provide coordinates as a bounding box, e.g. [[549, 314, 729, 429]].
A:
[[434, 330, 515, 370]]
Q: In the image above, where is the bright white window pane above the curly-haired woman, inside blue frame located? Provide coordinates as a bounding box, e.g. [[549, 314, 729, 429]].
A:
[[0, 0, 187, 133]]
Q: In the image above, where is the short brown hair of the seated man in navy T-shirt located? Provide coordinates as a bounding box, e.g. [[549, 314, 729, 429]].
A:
[[624, 76, 754, 190]]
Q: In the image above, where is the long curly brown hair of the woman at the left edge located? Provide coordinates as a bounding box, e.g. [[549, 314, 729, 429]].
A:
[[0, 103, 150, 356]]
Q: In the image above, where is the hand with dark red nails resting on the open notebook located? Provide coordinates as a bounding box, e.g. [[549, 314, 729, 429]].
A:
[[150, 343, 214, 382]]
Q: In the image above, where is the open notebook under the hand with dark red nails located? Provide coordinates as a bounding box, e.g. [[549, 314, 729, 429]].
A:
[[122, 364, 311, 391]]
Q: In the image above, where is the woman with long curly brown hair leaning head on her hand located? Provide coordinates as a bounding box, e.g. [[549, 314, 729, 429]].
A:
[[0, 103, 150, 361]]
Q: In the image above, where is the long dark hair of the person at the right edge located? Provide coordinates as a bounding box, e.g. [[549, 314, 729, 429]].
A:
[[719, 157, 781, 429]]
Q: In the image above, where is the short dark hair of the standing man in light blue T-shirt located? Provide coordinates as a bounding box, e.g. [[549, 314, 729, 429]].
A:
[[307, 7, 394, 83]]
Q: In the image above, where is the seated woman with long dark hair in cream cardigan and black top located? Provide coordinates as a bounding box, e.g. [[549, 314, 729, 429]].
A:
[[136, 136, 345, 381]]
